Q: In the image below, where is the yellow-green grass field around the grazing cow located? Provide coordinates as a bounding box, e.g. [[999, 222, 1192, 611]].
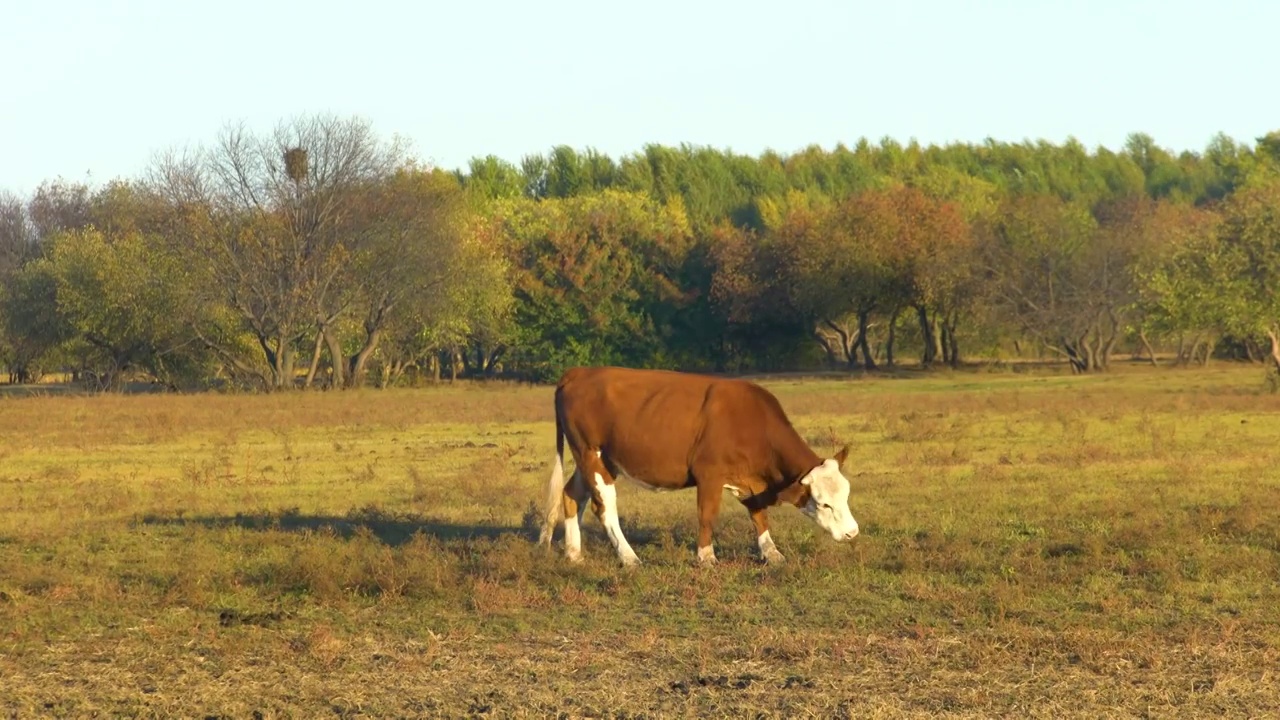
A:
[[0, 365, 1280, 719]]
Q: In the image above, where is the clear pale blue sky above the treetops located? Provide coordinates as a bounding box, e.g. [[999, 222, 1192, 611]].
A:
[[0, 0, 1280, 193]]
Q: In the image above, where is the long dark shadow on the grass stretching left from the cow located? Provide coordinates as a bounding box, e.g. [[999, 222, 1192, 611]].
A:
[[140, 509, 538, 547]]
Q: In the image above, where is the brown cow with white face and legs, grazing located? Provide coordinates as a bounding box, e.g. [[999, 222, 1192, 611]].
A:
[[538, 368, 858, 565]]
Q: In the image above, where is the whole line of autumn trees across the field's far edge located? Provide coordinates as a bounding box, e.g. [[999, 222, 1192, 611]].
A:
[[0, 115, 1280, 389]]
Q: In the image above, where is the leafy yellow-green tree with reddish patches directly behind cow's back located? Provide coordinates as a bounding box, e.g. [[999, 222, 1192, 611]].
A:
[[488, 190, 691, 378]]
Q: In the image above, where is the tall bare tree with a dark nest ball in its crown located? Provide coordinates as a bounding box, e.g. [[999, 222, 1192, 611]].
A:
[[151, 115, 404, 388]]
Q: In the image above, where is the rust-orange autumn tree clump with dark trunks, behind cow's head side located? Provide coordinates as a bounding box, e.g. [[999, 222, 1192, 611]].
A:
[[717, 186, 972, 369]]
